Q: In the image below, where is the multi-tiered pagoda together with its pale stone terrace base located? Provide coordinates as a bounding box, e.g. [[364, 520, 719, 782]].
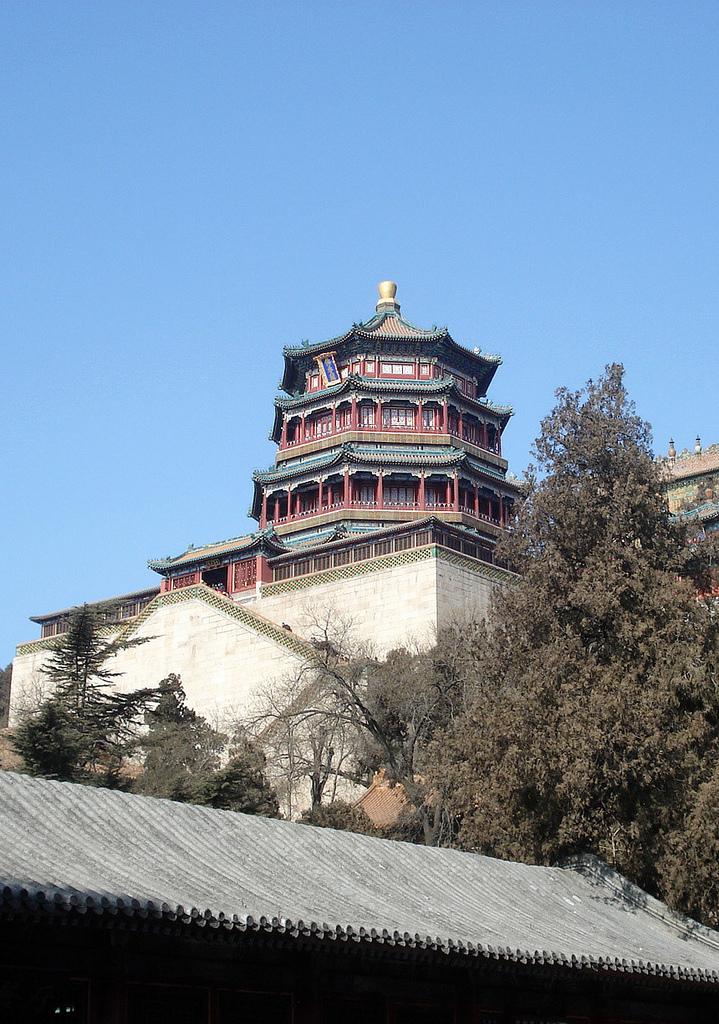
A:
[[11, 282, 519, 718]]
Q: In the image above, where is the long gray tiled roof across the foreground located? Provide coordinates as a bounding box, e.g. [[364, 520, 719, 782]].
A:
[[0, 772, 719, 984]]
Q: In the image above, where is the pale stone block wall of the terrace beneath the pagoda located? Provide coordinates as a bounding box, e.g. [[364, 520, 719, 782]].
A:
[[10, 545, 511, 722]]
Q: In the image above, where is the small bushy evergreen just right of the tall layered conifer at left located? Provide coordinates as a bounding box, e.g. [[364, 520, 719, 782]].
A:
[[135, 676, 227, 800]]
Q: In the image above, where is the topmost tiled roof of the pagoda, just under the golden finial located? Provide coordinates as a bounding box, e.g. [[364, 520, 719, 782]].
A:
[[281, 308, 502, 394]]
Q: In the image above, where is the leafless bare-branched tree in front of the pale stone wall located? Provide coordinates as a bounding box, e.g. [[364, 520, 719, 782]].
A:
[[247, 608, 473, 845]]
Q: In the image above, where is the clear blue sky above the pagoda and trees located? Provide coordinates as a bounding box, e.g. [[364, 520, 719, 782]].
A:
[[0, 0, 719, 663]]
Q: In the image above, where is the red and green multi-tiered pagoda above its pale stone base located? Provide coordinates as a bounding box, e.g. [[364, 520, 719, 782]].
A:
[[150, 281, 518, 597]]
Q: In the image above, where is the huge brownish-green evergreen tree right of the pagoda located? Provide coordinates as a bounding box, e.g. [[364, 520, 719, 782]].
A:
[[431, 366, 719, 891]]
